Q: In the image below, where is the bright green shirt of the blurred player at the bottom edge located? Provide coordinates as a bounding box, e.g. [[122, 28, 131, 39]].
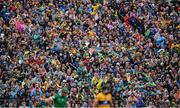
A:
[[53, 93, 67, 108]]
